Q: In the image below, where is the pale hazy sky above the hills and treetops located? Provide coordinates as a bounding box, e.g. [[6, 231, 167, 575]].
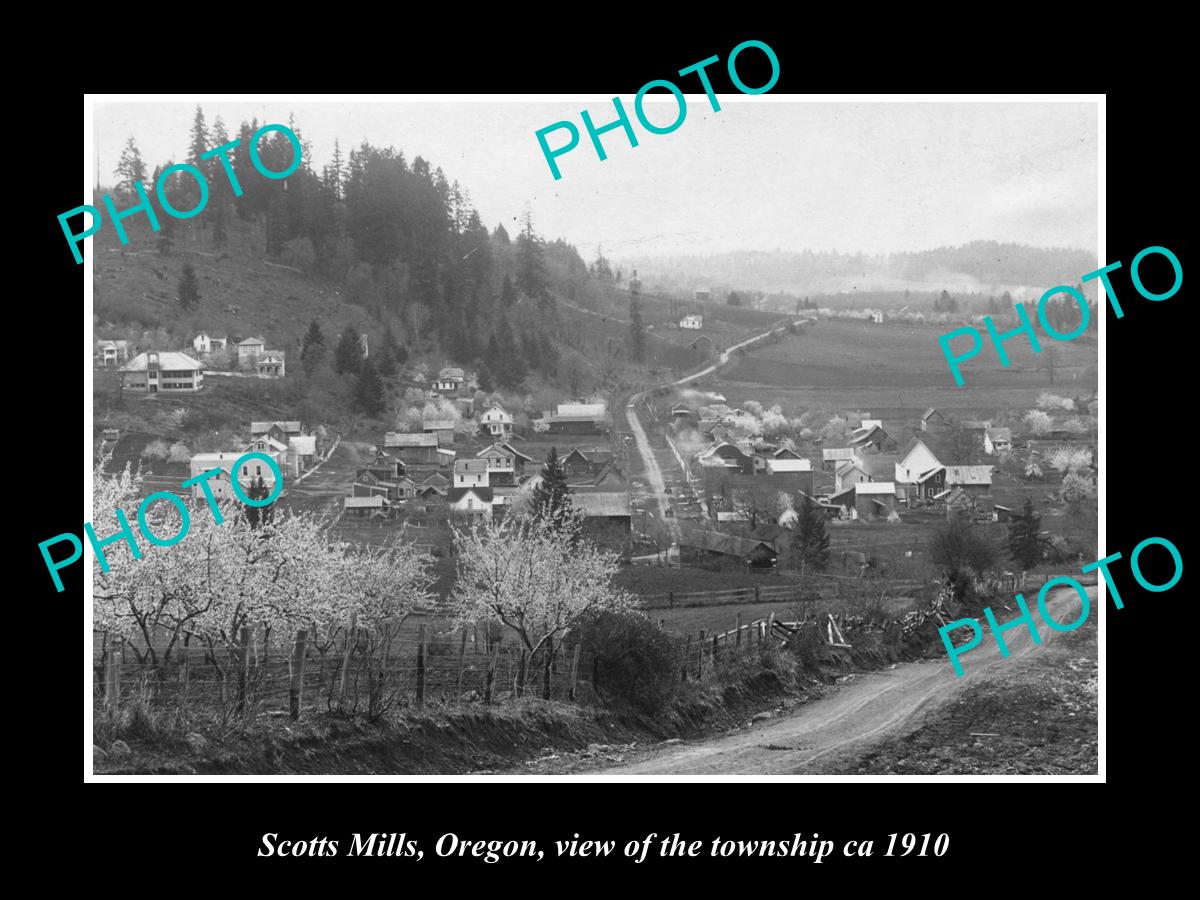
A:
[[95, 100, 1098, 259]]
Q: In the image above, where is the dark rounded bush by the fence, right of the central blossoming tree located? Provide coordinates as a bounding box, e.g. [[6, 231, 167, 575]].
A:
[[578, 610, 684, 714]]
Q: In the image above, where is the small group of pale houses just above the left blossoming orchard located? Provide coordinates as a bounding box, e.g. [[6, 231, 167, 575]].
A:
[[190, 421, 324, 499]]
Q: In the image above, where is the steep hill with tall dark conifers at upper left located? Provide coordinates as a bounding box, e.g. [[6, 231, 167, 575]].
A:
[[92, 108, 604, 386]]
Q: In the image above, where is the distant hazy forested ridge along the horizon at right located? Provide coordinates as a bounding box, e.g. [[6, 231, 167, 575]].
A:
[[622, 241, 1097, 294]]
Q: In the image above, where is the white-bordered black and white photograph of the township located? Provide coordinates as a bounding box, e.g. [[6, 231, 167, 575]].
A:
[[79, 95, 1099, 781]]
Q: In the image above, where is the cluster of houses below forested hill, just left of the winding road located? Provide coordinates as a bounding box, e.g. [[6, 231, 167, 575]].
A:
[[343, 400, 632, 551]]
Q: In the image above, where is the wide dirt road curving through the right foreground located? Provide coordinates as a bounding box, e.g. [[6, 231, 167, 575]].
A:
[[592, 587, 1097, 775]]
